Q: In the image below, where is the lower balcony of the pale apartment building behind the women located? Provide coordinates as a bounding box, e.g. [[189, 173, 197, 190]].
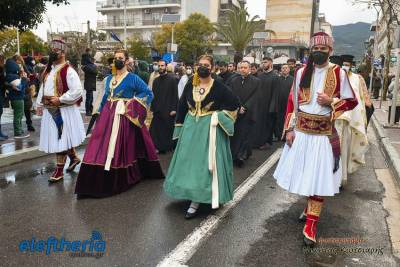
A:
[[97, 19, 161, 30]]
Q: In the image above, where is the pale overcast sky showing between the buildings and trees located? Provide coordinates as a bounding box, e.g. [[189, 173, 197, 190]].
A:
[[34, 0, 376, 40]]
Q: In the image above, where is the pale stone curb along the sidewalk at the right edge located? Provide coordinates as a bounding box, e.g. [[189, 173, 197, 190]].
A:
[[371, 114, 400, 187]]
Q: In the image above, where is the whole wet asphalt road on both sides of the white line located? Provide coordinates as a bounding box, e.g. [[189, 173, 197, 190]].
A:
[[0, 129, 400, 266]]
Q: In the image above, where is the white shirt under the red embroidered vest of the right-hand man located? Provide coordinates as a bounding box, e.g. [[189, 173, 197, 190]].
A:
[[296, 64, 354, 115]]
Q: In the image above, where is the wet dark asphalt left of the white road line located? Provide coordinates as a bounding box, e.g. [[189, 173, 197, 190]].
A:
[[0, 141, 275, 266]]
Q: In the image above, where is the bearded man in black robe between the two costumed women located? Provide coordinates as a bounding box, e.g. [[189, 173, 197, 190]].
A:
[[150, 60, 178, 153]]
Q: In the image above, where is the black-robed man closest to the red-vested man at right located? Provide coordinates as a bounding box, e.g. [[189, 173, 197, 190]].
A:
[[274, 64, 294, 138]]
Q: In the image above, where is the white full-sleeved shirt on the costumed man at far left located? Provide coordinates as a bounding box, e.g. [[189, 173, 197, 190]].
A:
[[36, 63, 83, 106]]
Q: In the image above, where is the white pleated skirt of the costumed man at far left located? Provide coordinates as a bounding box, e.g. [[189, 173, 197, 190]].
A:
[[39, 105, 86, 153]]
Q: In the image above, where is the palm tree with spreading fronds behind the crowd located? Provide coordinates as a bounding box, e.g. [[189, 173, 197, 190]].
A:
[[216, 4, 275, 61]]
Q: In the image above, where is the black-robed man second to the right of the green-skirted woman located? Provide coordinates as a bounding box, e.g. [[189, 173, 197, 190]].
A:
[[251, 57, 278, 149]]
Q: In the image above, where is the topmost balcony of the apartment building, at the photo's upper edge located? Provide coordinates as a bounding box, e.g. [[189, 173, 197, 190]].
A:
[[96, 0, 181, 13]]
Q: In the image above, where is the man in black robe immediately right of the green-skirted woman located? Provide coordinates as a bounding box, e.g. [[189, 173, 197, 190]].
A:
[[230, 61, 261, 167]]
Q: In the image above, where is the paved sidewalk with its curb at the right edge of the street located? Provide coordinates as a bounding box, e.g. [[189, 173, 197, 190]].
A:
[[370, 100, 400, 186]]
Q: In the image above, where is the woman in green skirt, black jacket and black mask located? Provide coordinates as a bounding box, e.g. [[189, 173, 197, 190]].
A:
[[164, 55, 239, 219]]
